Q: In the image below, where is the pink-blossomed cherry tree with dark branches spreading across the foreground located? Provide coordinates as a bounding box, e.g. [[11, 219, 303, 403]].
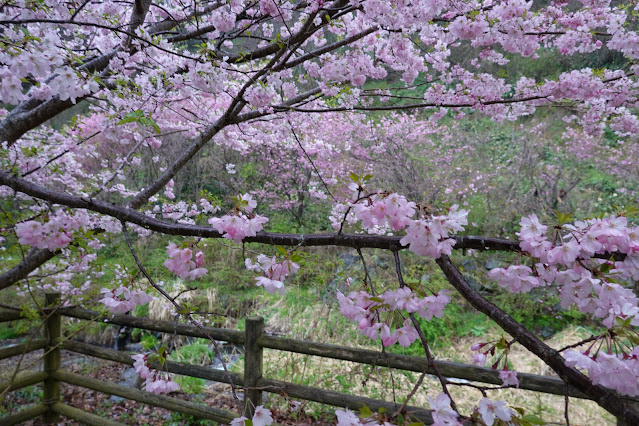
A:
[[0, 0, 639, 424]]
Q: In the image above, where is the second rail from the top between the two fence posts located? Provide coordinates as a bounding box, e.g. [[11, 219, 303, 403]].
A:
[[62, 340, 244, 386]]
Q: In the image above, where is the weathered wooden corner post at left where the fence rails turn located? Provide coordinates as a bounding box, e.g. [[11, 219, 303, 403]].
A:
[[42, 293, 62, 423]]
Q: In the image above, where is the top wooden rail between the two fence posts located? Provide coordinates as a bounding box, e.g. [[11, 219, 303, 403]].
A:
[[60, 308, 244, 344]]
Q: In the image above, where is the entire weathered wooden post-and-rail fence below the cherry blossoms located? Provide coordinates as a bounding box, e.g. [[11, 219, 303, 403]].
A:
[[0, 293, 636, 426]]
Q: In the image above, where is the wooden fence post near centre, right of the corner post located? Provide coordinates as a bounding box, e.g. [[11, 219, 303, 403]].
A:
[[244, 317, 264, 419]]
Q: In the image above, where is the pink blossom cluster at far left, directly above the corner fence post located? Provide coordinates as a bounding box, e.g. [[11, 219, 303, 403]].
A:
[[15, 211, 89, 251]]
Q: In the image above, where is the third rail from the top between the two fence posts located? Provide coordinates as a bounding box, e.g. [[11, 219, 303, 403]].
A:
[[53, 370, 238, 423]]
